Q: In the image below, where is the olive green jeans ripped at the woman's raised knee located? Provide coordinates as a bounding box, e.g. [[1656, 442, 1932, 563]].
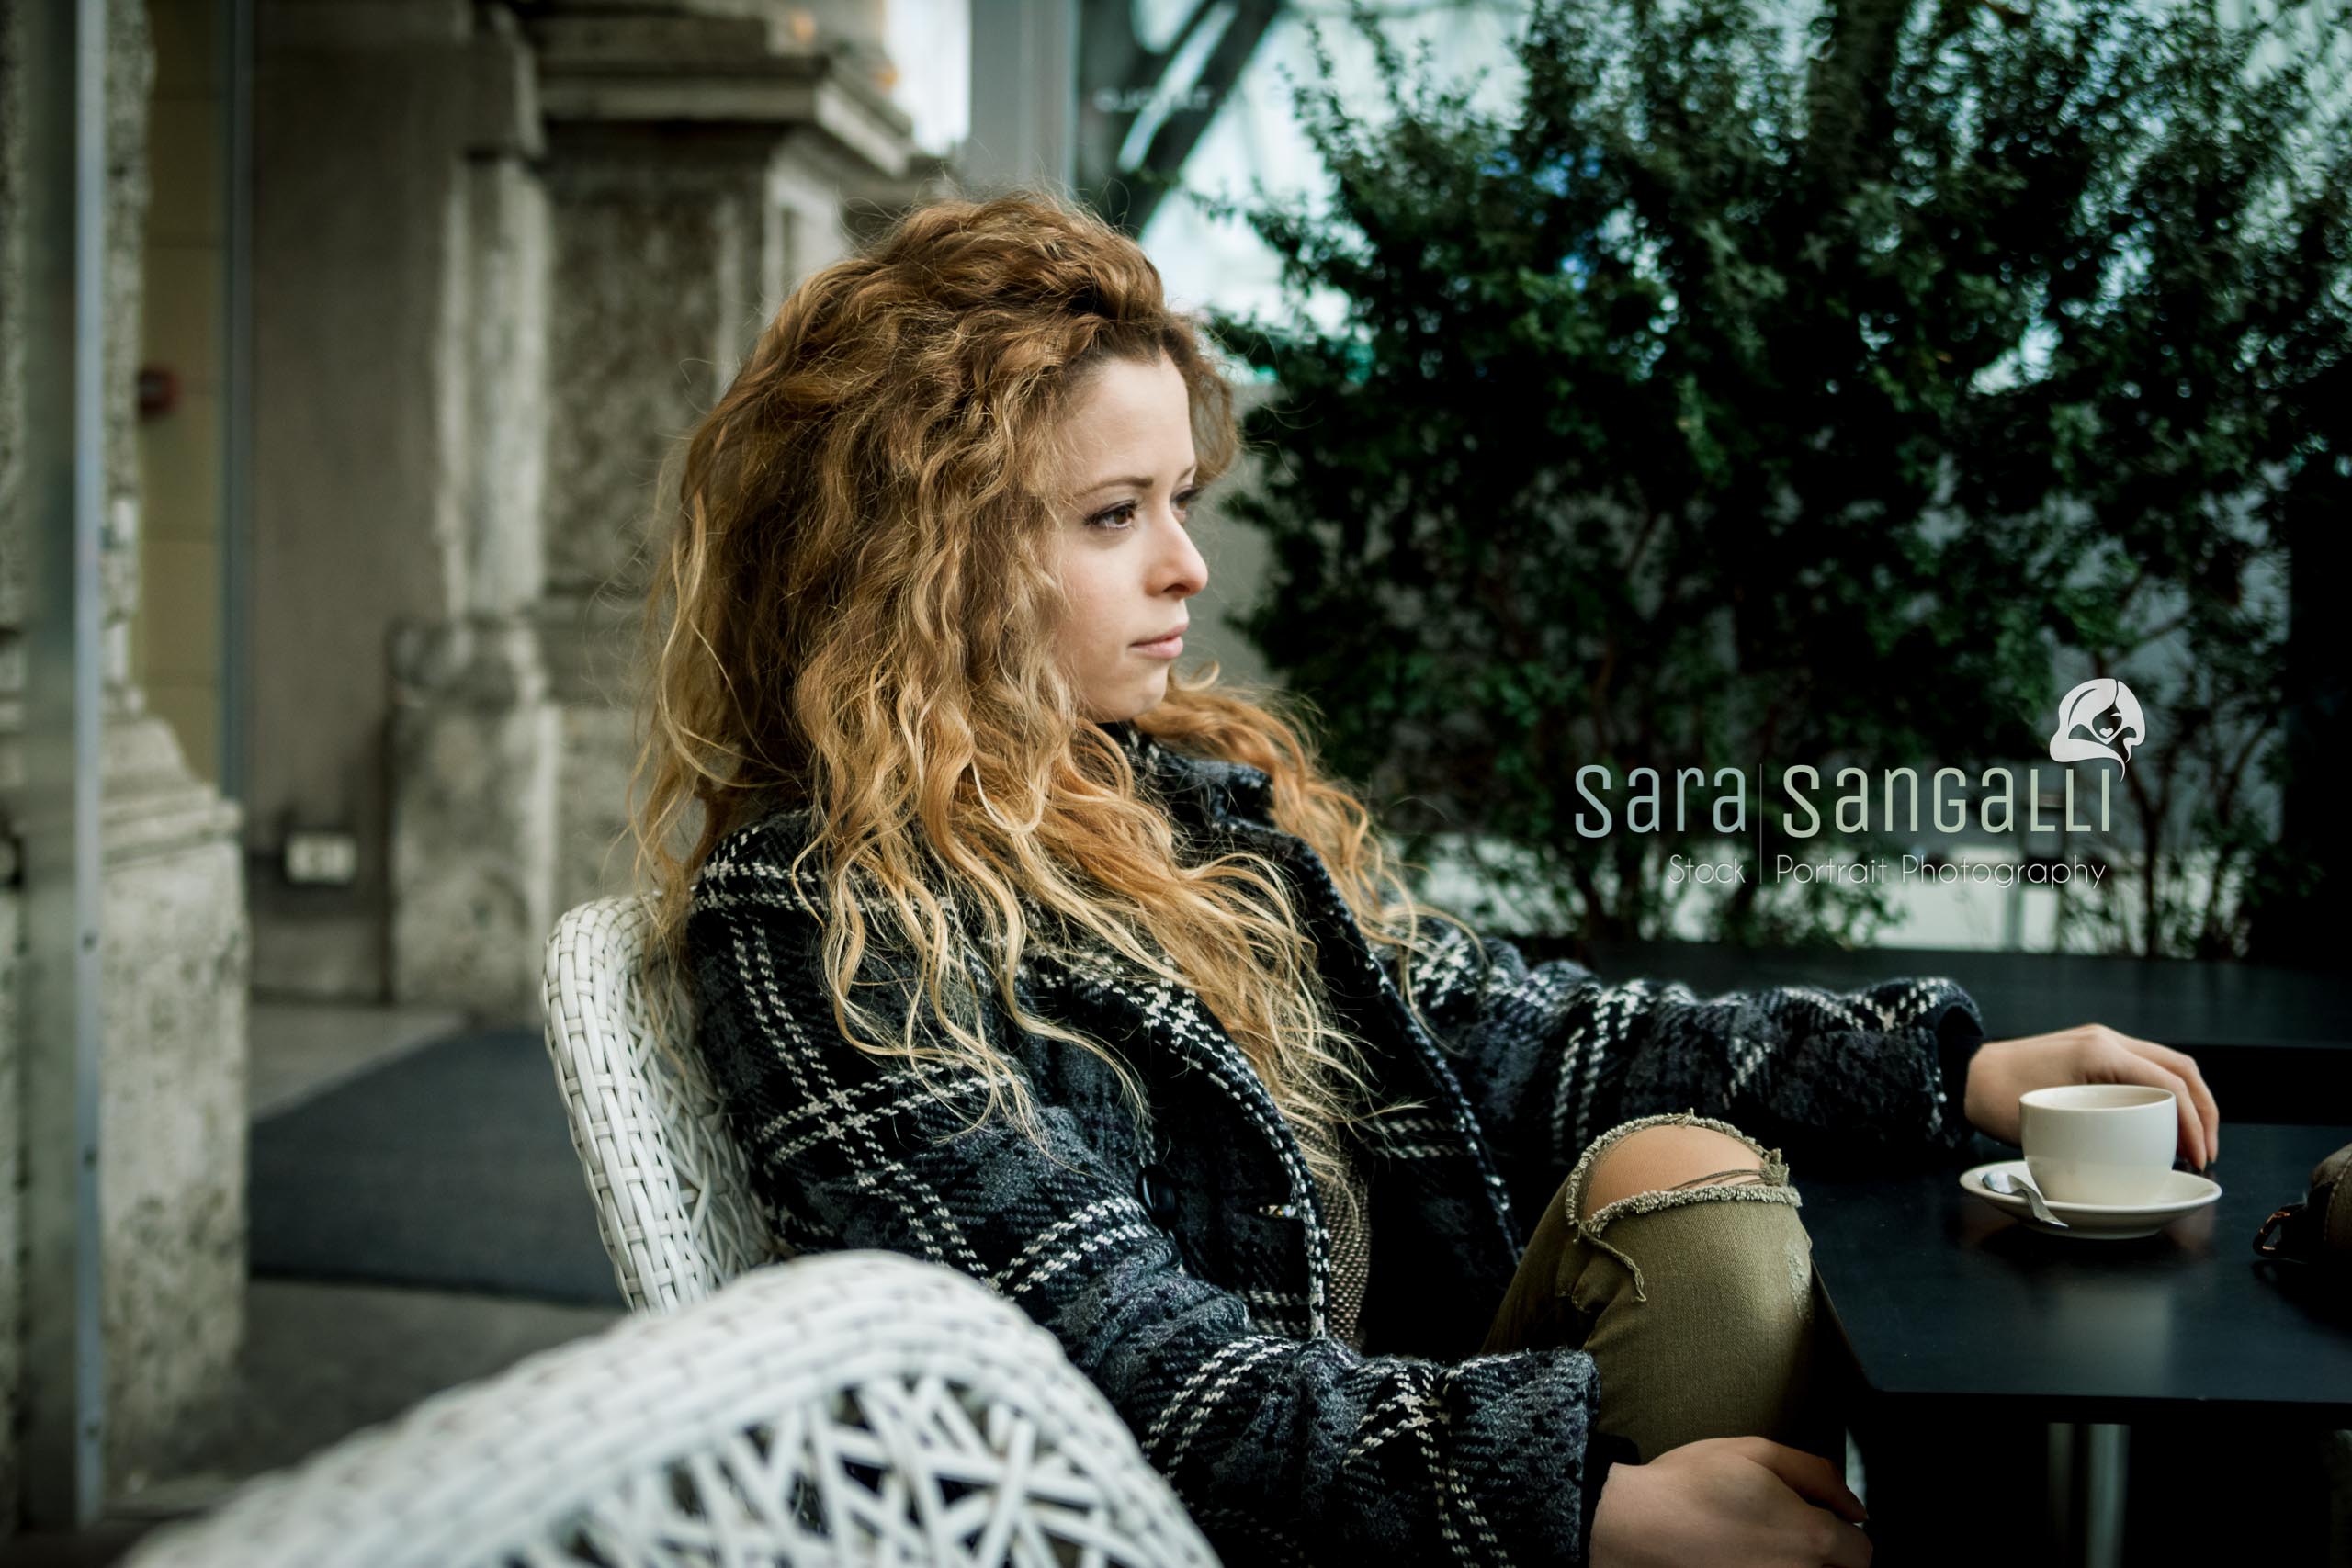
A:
[[1482, 1112, 1847, 1464]]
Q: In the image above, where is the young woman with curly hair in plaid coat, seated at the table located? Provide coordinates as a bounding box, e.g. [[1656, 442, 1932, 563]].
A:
[[639, 195, 2218, 1568]]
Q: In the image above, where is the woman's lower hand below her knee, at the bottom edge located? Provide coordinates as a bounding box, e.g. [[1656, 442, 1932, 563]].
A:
[[1585, 1437, 1872, 1568]]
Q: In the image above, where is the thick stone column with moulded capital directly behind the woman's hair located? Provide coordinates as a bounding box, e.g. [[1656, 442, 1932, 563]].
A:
[[393, 0, 912, 1016]]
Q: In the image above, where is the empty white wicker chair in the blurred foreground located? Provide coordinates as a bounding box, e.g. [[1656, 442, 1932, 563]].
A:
[[125, 1251, 1216, 1568]]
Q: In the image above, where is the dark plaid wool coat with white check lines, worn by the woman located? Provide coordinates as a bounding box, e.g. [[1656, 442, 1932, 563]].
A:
[[687, 724, 1981, 1568]]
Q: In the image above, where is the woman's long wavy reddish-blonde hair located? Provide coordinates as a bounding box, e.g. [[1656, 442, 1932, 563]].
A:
[[630, 193, 1467, 1213]]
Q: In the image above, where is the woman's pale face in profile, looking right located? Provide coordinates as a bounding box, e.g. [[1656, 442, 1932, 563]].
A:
[[1058, 355, 1209, 724]]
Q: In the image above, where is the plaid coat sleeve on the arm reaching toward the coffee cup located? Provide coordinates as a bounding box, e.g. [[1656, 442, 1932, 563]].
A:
[[1411, 921, 1983, 1213]]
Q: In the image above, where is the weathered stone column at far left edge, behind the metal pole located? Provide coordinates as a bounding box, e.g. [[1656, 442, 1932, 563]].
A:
[[0, 0, 247, 1517]]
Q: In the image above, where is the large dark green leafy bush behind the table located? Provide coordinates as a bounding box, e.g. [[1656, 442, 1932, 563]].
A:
[[1197, 0, 2352, 952]]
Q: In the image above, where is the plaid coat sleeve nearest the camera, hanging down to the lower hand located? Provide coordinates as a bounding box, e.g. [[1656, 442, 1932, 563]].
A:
[[687, 858, 1630, 1568]]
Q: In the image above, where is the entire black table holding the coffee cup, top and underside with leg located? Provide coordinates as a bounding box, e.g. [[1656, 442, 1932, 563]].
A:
[[1794, 1123, 2352, 1568]]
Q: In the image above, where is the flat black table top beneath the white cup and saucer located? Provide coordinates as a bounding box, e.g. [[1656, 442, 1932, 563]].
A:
[[1794, 1123, 2352, 1427]]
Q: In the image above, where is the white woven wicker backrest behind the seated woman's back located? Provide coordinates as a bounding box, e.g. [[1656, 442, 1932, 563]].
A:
[[546, 896, 790, 1312]]
